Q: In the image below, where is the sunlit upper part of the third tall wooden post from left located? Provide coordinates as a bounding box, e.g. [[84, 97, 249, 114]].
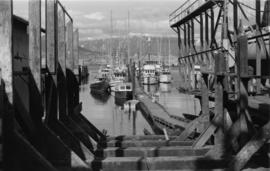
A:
[[46, 0, 57, 73]]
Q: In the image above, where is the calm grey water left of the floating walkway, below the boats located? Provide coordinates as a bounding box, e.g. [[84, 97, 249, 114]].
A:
[[80, 70, 153, 136]]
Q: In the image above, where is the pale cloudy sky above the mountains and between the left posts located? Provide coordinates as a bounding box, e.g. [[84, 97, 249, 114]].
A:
[[14, 0, 185, 40]]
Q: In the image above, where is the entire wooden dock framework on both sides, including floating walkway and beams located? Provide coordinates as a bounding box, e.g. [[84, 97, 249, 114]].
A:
[[0, 0, 270, 171]]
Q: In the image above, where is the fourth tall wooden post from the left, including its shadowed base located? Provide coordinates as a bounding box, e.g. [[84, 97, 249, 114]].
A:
[[57, 7, 67, 119]]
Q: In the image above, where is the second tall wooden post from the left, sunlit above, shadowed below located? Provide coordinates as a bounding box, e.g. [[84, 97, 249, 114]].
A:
[[28, 0, 43, 121]]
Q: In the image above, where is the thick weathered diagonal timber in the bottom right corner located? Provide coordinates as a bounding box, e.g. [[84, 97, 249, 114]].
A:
[[229, 122, 270, 170]]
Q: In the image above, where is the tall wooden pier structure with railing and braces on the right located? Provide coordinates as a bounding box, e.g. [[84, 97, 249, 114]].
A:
[[170, 0, 270, 170]]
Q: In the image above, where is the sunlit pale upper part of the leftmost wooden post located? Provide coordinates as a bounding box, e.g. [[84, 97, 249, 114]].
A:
[[0, 0, 13, 104]]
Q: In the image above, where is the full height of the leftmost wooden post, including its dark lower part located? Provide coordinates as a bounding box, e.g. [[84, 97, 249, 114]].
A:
[[0, 0, 14, 170]]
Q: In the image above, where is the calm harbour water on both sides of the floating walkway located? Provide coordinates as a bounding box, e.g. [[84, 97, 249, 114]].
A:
[[80, 69, 200, 136]]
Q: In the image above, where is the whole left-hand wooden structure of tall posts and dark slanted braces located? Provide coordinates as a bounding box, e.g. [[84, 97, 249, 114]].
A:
[[0, 0, 105, 171]]
